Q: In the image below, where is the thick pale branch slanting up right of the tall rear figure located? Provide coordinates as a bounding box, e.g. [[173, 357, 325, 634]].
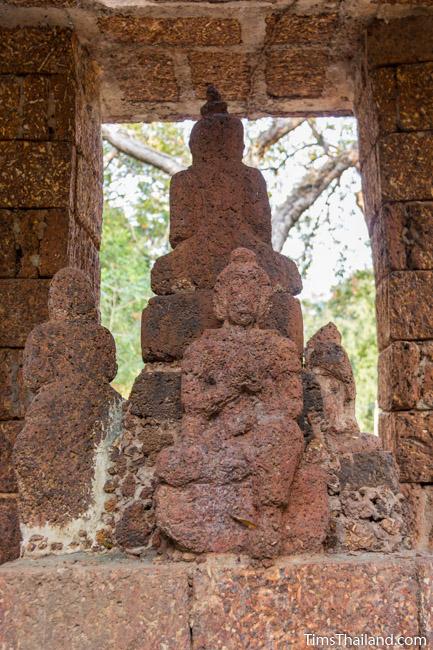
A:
[[272, 144, 358, 251]]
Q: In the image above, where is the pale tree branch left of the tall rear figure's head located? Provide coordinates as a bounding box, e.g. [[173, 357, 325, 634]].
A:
[[101, 125, 186, 176]]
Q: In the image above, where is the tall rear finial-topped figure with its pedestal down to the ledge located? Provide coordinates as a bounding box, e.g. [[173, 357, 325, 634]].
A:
[[114, 88, 303, 553]]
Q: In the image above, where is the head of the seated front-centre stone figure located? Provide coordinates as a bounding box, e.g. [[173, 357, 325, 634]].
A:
[[214, 248, 272, 327]]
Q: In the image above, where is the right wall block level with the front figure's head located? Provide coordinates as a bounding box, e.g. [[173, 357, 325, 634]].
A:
[[376, 271, 433, 350]]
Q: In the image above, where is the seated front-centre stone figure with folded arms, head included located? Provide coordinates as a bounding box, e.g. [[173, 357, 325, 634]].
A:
[[156, 248, 304, 557]]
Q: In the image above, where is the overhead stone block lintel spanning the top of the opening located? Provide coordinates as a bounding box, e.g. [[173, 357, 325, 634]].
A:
[[0, 0, 433, 122]]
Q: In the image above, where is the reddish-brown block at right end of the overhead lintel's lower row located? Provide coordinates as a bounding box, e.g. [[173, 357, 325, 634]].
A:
[[265, 47, 329, 97]]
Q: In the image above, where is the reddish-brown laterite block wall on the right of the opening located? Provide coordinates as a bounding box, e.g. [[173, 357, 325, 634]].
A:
[[356, 17, 433, 546]]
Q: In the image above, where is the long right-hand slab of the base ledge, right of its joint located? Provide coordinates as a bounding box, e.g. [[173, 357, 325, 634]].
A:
[[192, 556, 418, 650]]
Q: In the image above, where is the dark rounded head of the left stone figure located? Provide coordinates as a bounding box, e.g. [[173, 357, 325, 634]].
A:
[[48, 266, 99, 322]]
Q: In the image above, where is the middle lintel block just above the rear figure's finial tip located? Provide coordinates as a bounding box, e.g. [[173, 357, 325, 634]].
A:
[[188, 50, 250, 101]]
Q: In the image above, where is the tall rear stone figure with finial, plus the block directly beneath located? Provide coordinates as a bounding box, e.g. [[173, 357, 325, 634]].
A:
[[142, 87, 303, 361]]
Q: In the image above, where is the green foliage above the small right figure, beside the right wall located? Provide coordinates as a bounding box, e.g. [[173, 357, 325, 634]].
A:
[[303, 270, 377, 432]]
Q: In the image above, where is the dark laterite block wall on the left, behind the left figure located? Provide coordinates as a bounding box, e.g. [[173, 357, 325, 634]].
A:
[[0, 28, 102, 562]]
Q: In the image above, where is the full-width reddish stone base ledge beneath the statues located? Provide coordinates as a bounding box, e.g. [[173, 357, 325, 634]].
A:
[[0, 553, 433, 650]]
